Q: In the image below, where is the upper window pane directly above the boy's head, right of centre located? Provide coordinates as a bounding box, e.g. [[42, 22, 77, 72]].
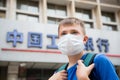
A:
[[75, 8, 92, 20]]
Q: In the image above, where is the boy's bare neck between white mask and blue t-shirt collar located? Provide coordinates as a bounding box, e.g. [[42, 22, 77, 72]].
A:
[[68, 51, 84, 68]]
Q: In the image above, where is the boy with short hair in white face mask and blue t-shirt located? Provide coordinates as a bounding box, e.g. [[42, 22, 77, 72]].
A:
[[49, 18, 119, 80]]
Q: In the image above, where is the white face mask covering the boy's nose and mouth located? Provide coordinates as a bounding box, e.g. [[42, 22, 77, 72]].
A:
[[58, 34, 85, 55]]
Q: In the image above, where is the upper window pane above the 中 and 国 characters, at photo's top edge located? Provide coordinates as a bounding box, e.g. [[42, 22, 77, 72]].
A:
[[17, 0, 39, 13]]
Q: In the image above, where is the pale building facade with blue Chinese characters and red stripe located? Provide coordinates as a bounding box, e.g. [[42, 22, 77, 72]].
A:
[[0, 0, 120, 80]]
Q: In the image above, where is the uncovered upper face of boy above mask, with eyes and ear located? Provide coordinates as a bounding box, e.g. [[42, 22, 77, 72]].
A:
[[58, 25, 88, 43]]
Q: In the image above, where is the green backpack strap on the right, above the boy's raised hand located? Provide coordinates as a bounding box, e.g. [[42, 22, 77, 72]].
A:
[[83, 53, 96, 66]]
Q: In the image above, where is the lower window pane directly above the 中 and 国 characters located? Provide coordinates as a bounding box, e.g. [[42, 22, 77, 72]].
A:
[[17, 13, 38, 22]]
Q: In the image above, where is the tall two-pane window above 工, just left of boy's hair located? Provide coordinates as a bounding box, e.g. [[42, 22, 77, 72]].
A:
[[47, 4, 67, 24]]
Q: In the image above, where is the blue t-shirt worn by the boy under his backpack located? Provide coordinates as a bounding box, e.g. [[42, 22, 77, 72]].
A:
[[67, 54, 119, 80]]
